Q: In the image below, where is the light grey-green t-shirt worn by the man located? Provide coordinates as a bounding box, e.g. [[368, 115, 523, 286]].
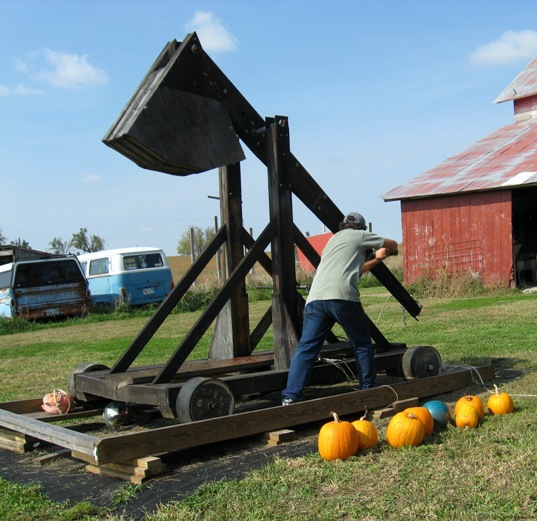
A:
[[307, 228, 385, 302]]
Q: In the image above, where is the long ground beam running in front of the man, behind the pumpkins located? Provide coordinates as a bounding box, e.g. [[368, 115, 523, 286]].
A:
[[95, 366, 494, 464]]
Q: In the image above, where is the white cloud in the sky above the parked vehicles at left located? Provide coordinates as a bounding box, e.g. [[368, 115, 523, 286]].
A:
[[30, 49, 108, 88]]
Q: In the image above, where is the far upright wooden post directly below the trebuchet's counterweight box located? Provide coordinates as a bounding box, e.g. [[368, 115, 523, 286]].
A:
[[209, 163, 250, 360]]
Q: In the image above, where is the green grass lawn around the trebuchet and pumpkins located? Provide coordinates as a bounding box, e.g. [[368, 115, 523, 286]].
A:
[[0, 288, 537, 521]]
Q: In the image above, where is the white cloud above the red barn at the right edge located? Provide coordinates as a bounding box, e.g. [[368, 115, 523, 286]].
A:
[[471, 29, 537, 67]]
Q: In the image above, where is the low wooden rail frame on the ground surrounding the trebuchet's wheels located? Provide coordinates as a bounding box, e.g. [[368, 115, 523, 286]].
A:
[[0, 366, 494, 465]]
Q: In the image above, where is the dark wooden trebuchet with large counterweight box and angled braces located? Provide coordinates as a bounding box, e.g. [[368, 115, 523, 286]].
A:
[[63, 33, 428, 417]]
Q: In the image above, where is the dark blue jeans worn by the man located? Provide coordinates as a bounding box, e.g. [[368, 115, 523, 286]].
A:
[[282, 300, 376, 401]]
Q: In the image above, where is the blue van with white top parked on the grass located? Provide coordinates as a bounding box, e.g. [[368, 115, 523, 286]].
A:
[[78, 247, 173, 309]]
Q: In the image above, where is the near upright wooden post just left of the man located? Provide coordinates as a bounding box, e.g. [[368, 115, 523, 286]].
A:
[[265, 116, 301, 370]]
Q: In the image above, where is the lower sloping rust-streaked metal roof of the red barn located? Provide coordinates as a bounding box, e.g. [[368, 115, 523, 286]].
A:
[[383, 119, 537, 201]]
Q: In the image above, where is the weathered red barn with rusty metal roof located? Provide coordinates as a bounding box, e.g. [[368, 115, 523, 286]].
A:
[[383, 59, 537, 287]]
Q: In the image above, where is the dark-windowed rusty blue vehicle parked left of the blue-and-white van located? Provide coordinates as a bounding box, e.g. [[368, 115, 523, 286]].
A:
[[0, 256, 90, 320]]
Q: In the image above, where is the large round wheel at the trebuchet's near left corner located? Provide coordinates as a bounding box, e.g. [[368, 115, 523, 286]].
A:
[[176, 376, 235, 423]]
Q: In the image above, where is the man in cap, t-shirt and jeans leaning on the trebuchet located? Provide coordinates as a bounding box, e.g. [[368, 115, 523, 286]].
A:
[[282, 212, 397, 405]]
